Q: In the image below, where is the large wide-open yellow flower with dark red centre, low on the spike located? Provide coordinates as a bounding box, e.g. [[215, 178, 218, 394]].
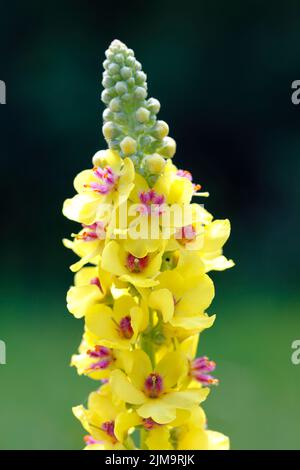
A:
[[110, 350, 209, 424]]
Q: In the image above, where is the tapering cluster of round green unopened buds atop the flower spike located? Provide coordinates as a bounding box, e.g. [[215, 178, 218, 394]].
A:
[[101, 40, 176, 179]]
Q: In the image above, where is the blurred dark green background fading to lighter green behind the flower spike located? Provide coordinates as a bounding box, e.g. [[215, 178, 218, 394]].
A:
[[0, 0, 300, 449]]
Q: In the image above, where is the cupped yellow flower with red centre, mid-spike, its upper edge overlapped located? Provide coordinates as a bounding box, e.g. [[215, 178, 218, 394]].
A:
[[101, 240, 163, 287]]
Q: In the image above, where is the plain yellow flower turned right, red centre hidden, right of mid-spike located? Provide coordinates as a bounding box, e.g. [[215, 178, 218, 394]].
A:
[[149, 270, 215, 334]]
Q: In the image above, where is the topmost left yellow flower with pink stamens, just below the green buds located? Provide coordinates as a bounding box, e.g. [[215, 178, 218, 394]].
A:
[[63, 150, 134, 225]]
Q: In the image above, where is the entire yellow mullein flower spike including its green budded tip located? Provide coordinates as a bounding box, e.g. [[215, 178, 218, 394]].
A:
[[63, 40, 233, 450]]
